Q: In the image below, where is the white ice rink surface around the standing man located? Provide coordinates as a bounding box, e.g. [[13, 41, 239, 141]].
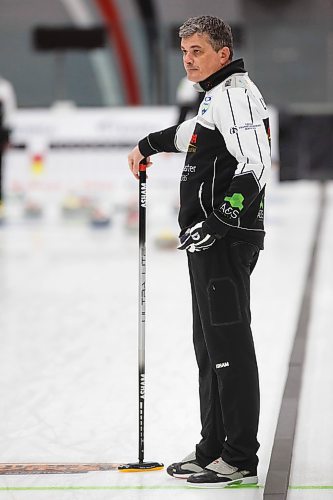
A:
[[0, 149, 333, 500]]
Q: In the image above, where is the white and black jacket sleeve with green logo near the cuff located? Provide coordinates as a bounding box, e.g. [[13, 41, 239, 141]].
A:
[[206, 88, 271, 236]]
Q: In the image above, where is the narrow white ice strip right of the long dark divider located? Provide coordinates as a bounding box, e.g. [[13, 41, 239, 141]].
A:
[[288, 182, 333, 500]]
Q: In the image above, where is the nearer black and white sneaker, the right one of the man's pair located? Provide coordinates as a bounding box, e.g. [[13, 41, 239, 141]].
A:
[[186, 458, 258, 488]]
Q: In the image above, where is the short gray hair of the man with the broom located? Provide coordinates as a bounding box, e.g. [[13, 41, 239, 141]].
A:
[[179, 16, 233, 59]]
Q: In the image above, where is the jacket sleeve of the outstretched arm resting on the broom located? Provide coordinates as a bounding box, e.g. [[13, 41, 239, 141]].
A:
[[139, 117, 196, 158]]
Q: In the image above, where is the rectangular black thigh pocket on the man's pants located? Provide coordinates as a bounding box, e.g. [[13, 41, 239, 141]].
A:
[[207, 278, 242, 326]]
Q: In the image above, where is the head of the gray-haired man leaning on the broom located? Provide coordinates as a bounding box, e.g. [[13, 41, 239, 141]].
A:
[[179, 16, 233, 82]]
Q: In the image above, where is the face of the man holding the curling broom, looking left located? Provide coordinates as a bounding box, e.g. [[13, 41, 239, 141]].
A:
[[181, 33, 230, 82]]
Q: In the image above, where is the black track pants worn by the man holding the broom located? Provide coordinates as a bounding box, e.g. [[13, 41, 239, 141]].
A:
[[188, 238, 259, 469]]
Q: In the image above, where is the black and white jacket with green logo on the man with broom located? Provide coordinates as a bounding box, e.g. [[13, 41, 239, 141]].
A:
[[139, 59, 271, 248]]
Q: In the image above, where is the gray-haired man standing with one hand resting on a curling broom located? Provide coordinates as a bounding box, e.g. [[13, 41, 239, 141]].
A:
[[128, 16, 270, 487]]
